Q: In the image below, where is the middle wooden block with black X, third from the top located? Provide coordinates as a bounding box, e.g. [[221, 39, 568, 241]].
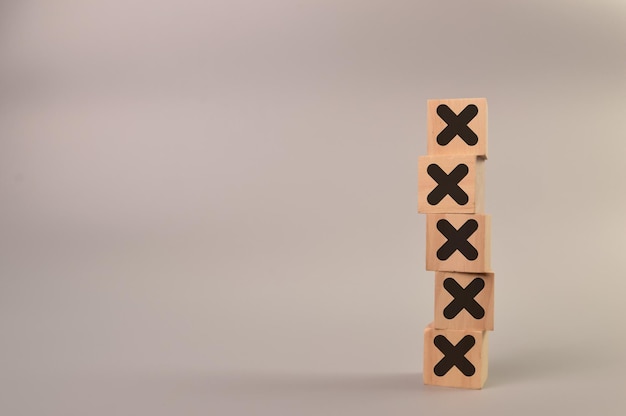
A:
[[426, 214, 491, 273]]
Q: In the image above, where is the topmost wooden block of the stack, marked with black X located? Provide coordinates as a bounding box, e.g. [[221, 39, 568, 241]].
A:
[[426, 98, 487, 159]]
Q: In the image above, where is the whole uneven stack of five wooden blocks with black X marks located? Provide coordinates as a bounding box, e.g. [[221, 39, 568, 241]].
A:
[[418, 98, 494, 389]]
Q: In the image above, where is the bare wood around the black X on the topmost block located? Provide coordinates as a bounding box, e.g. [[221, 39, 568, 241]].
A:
[[426, 98, 488, 159]]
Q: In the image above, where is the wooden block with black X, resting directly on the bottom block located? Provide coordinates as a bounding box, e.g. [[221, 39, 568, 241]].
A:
[[433, 272, 494, 331]]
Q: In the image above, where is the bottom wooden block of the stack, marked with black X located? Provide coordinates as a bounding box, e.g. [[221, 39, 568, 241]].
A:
[[424, 324, 488, 389]]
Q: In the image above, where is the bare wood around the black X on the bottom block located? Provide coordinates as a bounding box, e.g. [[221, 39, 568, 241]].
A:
[[424, 324, 489, 389]]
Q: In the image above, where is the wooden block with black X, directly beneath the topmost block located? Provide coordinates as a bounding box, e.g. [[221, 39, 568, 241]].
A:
[[417, 155, 485, 214]]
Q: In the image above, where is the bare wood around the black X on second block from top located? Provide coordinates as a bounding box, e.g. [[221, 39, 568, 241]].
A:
[[417, 155, 485, 214]]
